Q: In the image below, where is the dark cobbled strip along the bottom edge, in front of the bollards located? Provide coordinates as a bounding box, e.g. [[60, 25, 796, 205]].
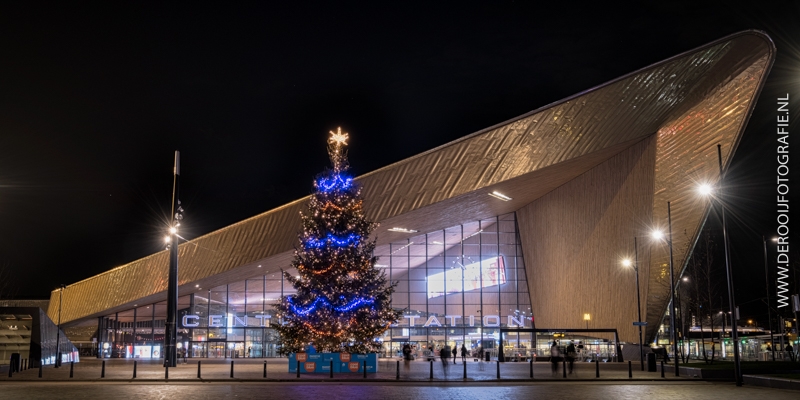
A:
[[0, 381, 797, 400]]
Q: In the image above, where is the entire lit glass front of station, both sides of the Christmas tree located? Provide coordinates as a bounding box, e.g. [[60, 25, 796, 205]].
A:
[[98, 213, 535, 358]]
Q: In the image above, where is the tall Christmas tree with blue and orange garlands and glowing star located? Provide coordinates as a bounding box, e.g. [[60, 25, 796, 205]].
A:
[[275, 128, 401, 353]]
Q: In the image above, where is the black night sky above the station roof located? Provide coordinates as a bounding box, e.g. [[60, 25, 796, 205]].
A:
[[0, 1, 800, 317]]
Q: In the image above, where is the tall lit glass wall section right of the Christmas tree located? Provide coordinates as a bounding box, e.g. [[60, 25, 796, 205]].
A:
[[375, 213, 532, 355]]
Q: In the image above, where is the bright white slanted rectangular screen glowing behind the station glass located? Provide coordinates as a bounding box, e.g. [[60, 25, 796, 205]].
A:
[[428, 256, 506, 299]]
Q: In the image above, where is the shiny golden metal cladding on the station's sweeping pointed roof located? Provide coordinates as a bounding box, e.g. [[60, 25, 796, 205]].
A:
[[49, 31, 774, 340]]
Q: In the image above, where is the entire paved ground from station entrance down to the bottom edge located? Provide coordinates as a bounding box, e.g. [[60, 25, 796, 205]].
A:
[[0, 358, 798, 400]]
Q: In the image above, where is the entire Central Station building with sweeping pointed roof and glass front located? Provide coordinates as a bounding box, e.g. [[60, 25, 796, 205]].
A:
[[48, 31, 775, 358]]
